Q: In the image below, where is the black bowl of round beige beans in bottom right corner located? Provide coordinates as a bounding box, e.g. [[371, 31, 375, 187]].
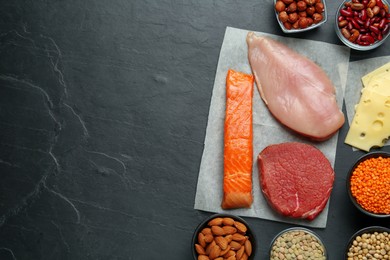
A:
[[344, 226, 390, 260]]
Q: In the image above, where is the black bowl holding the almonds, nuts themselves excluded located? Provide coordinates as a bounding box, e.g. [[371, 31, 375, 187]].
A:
[[191, 214, 257, 260]]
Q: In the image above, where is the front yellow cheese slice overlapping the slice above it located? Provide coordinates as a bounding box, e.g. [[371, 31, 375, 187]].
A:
[[345, 89, 390, 152]]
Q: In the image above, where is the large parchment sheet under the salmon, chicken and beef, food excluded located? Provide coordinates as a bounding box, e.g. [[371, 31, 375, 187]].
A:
[[194, 27, 350, 228]]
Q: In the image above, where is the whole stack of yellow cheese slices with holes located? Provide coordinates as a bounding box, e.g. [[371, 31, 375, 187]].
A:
[[345, 63, 390, 152]]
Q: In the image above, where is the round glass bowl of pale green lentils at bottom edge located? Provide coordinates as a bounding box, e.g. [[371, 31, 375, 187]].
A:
[[269, 227, 328, 260]]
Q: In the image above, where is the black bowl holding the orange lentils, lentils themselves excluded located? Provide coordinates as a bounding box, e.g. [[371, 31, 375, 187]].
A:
[[346, 152, 390, 218]]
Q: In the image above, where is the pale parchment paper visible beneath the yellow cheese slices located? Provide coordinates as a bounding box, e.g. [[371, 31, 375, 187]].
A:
[[344, 56, 390, 150]]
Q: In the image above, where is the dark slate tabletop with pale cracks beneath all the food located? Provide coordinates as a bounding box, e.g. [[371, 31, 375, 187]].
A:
[[0, 0, 390, 260]]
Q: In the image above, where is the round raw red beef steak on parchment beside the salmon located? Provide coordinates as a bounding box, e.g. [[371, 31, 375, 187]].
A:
[[257, 142, 334, 220]]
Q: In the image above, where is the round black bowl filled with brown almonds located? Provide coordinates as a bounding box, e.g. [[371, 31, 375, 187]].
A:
[[191, 214, 257, 260]]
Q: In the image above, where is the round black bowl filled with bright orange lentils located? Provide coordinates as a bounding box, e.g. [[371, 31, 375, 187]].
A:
[[346, 151, 390, 218]]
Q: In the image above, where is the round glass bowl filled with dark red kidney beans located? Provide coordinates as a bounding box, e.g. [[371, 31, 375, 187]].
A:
[[335, 0, 390, 51]]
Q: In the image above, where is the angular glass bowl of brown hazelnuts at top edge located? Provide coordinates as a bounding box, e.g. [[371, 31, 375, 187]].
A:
[[274, 0, 328, 33]]
